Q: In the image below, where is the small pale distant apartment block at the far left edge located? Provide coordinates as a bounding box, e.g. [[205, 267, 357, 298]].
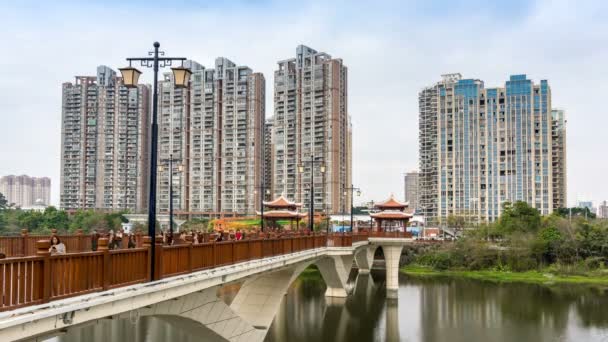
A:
[[0, 175, 51, 207]]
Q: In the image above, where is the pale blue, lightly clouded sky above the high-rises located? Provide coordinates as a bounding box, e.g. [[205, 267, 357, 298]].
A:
[[0, 0, 608, 205]]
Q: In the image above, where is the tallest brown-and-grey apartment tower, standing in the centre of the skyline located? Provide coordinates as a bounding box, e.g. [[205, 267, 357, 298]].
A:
[[272, 45, 352, 213]]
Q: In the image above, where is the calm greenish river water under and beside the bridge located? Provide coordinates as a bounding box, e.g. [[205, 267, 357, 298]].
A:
[[51, 272, 608, 342]]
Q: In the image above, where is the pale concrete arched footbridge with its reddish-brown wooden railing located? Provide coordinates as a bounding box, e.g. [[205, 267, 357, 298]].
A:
[[0, 232, 412, 341]]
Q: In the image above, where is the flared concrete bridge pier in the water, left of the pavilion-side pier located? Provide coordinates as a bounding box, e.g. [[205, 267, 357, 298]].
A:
[[316, 254, 353, 297]]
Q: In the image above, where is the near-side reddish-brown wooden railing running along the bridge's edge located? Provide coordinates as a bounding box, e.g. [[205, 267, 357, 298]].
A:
[[0, 232, 416, 311]]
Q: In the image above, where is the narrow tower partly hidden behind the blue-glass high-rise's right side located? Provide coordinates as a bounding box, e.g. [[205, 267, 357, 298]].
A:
[[551, 109, 568, 209]]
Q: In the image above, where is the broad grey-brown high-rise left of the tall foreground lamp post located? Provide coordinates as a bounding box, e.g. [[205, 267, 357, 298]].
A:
[[60, 66, 150, 211]]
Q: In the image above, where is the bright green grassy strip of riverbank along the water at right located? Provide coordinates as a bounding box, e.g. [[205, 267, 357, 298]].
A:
[[400, 265, 608, 286]]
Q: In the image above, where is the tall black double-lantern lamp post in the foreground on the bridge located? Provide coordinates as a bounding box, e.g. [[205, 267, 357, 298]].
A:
[[119, 42, 191, 280]]
